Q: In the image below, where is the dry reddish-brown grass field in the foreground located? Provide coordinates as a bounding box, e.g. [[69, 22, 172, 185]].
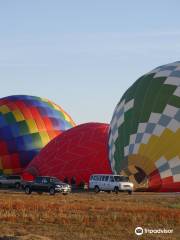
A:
[[0, 191, 180, 240]]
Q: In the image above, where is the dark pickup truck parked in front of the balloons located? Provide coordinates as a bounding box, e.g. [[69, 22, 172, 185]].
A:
[[22, 176, 71, 195]]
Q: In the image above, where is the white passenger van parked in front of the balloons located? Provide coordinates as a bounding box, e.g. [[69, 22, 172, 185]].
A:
[[89, 174, 134, 194]]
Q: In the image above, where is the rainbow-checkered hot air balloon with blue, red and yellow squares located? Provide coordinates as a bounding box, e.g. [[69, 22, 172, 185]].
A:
[[0, 95, 75, 174]]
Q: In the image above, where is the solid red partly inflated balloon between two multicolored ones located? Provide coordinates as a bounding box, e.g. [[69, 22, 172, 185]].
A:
[[24, 123, 112, 184]]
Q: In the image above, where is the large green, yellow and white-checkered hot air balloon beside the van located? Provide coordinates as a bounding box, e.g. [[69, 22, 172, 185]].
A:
[[109, 62, 180, 191]]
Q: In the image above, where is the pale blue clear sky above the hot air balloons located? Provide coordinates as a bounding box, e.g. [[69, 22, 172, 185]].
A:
[[0, 0, 180, 123]]
